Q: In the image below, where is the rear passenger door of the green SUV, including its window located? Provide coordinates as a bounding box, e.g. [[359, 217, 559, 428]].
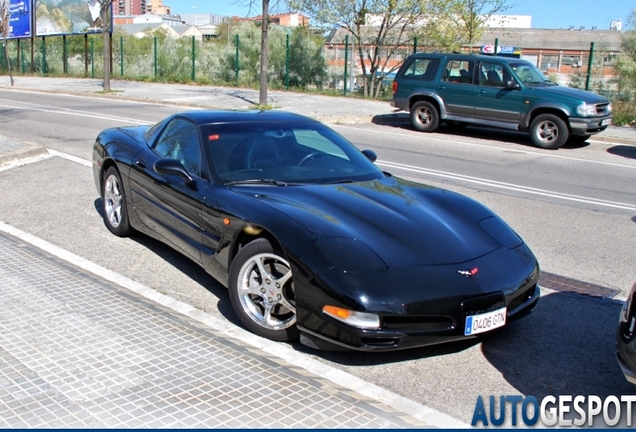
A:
[[437, 59, 475, 118]]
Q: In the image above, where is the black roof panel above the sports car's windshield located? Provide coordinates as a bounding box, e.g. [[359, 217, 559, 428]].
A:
[[175, 110, 317, 125]]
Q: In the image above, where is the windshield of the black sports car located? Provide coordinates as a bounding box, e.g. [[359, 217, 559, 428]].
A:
[[200, 121, 384, 185]]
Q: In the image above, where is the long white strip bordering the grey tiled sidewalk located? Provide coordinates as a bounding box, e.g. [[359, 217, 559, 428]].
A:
[[0, 221, 468, 428]]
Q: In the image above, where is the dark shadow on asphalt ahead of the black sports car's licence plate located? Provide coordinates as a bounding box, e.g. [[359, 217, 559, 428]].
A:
[[482, 293, 634, 398]]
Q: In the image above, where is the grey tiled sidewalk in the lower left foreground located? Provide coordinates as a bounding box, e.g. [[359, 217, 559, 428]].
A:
[[0, 223, 442, 429]]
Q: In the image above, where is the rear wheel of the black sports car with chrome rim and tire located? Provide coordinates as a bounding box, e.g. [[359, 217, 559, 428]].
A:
[[102, 167, 133, 237]]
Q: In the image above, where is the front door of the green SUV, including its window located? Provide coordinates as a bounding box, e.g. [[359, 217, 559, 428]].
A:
[[475, 62, 523, 124]]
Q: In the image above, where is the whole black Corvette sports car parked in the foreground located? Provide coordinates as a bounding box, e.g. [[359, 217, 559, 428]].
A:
[[93, 111, 540, 351]]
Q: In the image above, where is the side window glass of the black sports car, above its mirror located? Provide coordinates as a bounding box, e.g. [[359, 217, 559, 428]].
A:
[[153, 118, 201, 177]]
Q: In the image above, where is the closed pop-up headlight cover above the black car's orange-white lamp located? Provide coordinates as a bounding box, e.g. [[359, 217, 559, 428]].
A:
[[314, 237, 387, 272]]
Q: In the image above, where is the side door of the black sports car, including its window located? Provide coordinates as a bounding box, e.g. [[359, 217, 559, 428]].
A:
[[130, 117, 208, 263]]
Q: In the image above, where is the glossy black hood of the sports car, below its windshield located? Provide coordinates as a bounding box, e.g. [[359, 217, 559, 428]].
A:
[[234, 178, 522, 266]]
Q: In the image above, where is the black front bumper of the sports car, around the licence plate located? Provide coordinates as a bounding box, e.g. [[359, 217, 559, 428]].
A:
[[296, 245, 541, 351]]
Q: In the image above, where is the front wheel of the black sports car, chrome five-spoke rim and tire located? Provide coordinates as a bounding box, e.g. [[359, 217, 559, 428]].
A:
[[228, 239, 299, 341]]
